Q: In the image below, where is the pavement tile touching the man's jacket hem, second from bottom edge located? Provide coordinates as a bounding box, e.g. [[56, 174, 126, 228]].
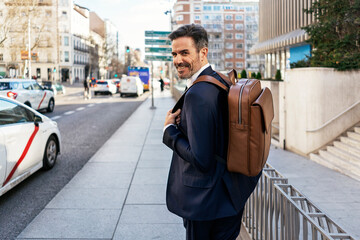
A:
[[119, 204, 182, 225]]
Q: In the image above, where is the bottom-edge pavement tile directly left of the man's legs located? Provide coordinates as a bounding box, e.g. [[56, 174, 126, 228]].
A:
[[113, 224, 186, 240]]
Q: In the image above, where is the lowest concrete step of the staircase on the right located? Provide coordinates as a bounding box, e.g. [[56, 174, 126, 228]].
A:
[[319, 150, 360, 179]]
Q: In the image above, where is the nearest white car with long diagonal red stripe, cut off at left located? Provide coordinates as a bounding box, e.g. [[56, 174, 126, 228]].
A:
[[0, 96, 61, 196]]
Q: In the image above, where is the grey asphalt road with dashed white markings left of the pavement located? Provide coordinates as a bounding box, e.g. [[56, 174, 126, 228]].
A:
[[0, 85, 149, 239]]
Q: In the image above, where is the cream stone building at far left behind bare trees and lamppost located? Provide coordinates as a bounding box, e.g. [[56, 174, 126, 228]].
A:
[[0, 0, 59, 81]]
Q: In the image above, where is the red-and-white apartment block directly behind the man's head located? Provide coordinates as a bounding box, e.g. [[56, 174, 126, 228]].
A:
[[172, 0, 265, 75]]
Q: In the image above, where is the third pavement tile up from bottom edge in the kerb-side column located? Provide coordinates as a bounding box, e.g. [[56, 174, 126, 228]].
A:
[[65, 170, 133, 188]]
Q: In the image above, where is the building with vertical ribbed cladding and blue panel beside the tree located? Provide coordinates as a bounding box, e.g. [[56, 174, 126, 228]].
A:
[[250, 0, 315, 78]]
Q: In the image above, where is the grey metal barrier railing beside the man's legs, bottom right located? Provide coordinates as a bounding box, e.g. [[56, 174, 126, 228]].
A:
[[242, 164, 354, 240]]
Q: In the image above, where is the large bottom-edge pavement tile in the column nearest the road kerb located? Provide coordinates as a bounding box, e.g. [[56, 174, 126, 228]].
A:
[[18, 209, 120, 239]]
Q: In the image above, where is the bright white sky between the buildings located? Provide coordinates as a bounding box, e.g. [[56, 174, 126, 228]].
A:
[[74, 0, 174, 56]]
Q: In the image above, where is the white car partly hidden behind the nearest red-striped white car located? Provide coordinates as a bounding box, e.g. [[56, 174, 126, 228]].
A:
[[0, 79, 55, 112]]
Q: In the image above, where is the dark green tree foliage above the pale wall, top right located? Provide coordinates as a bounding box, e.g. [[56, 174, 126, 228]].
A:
[[303, 0, 360, 70]]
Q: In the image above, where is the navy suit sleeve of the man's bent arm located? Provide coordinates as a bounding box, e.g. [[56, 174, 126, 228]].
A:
[[163, 83, 219, 172]]
